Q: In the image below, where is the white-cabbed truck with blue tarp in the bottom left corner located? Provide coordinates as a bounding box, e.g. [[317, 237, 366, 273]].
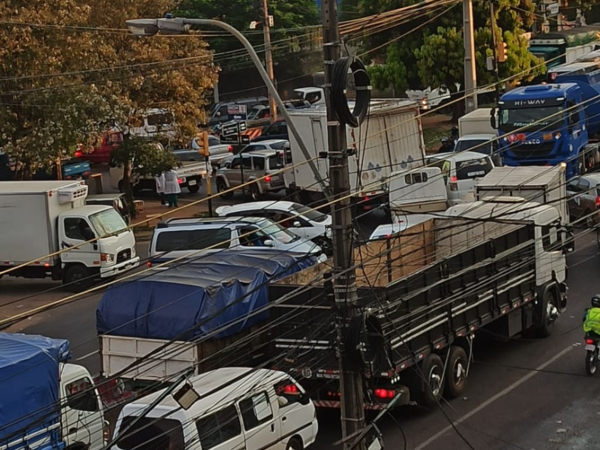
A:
[[0, 333, 108, 450]]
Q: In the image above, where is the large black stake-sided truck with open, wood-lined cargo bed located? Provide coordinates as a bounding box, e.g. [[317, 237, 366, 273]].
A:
[[269, 202, 567, 409]]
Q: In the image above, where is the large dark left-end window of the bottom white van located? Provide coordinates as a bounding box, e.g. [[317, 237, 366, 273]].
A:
[[116, 416, 185, 450]]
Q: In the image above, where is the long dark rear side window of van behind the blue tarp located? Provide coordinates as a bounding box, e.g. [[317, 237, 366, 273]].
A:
[[156, 228, 231, 252]]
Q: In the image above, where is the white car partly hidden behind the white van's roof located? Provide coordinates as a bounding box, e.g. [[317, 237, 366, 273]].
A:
[[216, 200, 331, 251]]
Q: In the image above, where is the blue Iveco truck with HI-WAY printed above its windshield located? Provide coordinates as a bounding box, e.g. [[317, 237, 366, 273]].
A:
[[492, 51, 600, 179]]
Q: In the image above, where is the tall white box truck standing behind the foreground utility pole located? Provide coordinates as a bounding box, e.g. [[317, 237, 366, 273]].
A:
[[284, 100, 425, 212]]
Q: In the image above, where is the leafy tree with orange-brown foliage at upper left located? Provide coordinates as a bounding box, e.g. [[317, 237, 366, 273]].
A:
[[0, 0, 217, 179]]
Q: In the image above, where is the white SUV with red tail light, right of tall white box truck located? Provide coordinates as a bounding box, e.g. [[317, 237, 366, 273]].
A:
[[426, 152, 494, 206]]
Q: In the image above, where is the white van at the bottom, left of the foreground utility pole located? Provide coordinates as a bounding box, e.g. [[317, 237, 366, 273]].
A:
[[113, 367, 319, 450]]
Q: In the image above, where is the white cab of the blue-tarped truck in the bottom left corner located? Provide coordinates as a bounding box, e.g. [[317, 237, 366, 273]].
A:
[[61, 375, 104, 450]]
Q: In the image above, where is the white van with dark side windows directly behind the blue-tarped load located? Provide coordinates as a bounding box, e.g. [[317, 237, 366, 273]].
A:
[[149, 217, 326, 262]]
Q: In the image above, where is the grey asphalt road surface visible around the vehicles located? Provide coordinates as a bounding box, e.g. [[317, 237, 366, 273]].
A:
[[0, 213, 600, 450]]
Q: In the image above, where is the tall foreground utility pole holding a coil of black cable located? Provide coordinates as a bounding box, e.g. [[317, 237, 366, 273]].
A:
[[321, 0, 365, 450]]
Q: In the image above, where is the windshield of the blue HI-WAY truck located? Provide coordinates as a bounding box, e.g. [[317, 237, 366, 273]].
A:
[[499, 106, 564, 133]]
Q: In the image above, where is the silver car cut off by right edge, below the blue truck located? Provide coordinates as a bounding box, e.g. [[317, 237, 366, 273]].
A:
[[567, 173, 600, 227]]
